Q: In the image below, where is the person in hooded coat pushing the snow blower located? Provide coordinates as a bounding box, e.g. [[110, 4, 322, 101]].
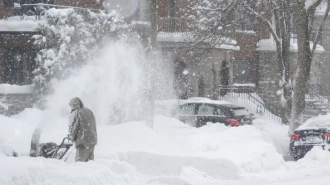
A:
[[69, 97, 97, 162]]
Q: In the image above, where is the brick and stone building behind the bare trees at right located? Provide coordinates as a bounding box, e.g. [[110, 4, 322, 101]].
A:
[[152, 0, 330, 115]]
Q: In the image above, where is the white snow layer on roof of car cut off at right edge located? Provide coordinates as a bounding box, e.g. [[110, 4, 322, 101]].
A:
[[296, 114, 330, 130]]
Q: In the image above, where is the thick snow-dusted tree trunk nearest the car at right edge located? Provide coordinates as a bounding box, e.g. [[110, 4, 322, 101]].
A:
[[289, 0, 312, 133]]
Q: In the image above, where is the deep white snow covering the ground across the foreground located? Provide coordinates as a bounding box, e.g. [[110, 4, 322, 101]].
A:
[[0, 109, 330, 185]]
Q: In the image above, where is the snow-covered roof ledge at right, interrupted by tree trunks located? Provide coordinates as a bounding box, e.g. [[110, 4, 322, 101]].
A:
[[257, 39, 325, 53]]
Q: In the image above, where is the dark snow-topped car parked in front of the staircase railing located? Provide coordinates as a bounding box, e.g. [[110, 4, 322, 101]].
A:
[[174, 99, 252, 127]]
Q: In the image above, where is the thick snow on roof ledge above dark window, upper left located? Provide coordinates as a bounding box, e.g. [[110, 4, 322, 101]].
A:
[[0, 16, 38, 32]]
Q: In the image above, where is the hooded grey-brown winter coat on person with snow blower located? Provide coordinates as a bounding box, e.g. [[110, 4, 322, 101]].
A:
[[69, 98, 97, 148]]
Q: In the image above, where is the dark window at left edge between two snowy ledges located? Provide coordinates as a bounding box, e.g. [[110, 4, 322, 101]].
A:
[[4, 48, 36, 85]]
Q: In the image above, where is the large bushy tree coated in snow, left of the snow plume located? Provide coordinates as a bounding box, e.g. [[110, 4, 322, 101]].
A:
[[33, 8, 129, 98]]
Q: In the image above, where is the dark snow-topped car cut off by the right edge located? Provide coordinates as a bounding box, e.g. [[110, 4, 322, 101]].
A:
[[290, 115, 330, 159]]
